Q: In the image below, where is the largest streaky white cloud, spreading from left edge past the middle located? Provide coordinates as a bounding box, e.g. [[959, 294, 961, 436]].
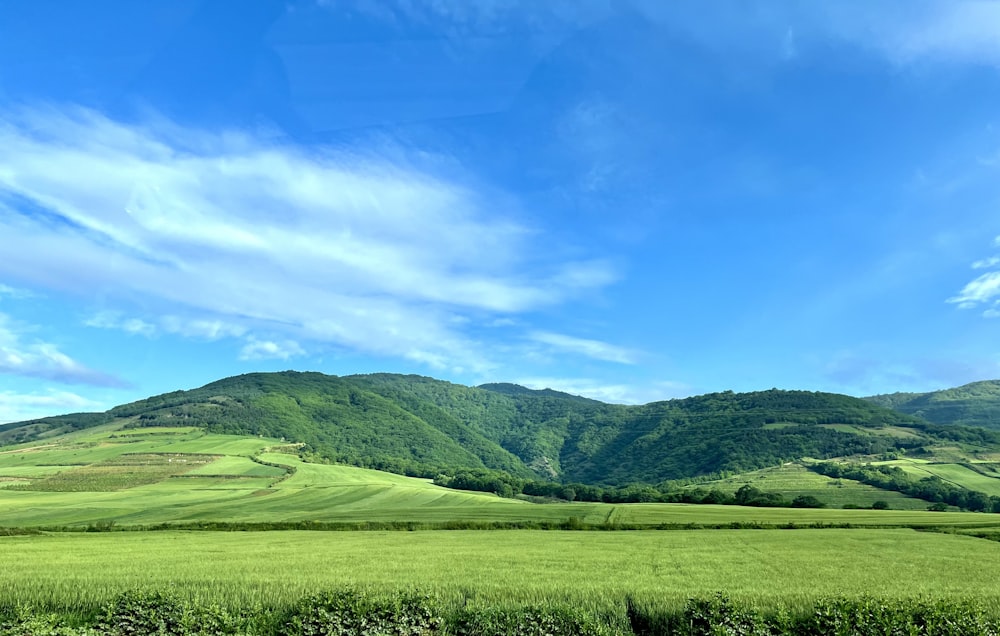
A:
[[0, 110, 615, 370]]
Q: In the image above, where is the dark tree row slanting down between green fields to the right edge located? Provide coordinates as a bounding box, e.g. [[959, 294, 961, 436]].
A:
[[809, 462, 1000, 512]]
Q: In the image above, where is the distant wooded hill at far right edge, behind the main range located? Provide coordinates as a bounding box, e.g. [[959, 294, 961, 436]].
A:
[[865, 380, 1000, 429]]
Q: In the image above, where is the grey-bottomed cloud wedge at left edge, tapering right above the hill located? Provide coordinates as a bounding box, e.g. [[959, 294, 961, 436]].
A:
[[0, 313, 124, 387]]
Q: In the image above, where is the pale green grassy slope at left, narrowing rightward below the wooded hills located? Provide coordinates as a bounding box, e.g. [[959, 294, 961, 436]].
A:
[[0, 426, 1000, 527]]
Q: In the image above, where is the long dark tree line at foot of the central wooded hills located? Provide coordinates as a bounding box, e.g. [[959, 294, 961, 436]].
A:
[[434, 469, 825, 508]]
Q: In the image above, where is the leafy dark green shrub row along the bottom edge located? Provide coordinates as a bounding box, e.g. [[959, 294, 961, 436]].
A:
[[0, 589, 1000, 636]]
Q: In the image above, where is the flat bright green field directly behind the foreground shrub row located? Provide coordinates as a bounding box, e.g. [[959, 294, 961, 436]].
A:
[[0, 530, 1000, 610]]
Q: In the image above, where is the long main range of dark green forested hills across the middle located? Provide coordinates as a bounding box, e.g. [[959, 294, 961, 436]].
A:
[[0, 371, 1000, 485]]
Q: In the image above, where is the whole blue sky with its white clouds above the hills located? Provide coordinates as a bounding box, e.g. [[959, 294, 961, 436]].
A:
[[0, 0, 1000, 421]]
